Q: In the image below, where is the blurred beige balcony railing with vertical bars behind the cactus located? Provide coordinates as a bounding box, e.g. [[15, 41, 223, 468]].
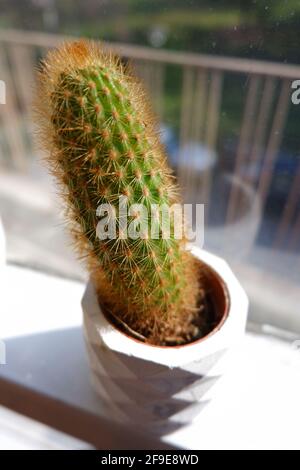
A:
[[0, 30, 300, 229]]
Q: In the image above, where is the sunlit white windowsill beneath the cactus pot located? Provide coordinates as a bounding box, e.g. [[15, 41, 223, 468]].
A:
[[0, 266, 300, 449]]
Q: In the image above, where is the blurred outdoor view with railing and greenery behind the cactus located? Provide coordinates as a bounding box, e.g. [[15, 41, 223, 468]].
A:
[[0, 0, 300, 332]]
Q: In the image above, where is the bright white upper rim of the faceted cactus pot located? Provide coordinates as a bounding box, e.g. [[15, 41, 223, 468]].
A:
[[82, 246, 248, 368]]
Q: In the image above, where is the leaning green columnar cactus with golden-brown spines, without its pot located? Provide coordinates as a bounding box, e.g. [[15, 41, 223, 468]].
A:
[[37, 40, 202, 345]]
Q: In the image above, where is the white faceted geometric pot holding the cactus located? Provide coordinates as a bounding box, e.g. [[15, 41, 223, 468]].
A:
[[82, 248, 248, 434]]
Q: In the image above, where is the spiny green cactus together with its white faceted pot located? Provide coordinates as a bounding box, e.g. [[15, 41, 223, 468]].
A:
[[36, 40, 248, 433]]
